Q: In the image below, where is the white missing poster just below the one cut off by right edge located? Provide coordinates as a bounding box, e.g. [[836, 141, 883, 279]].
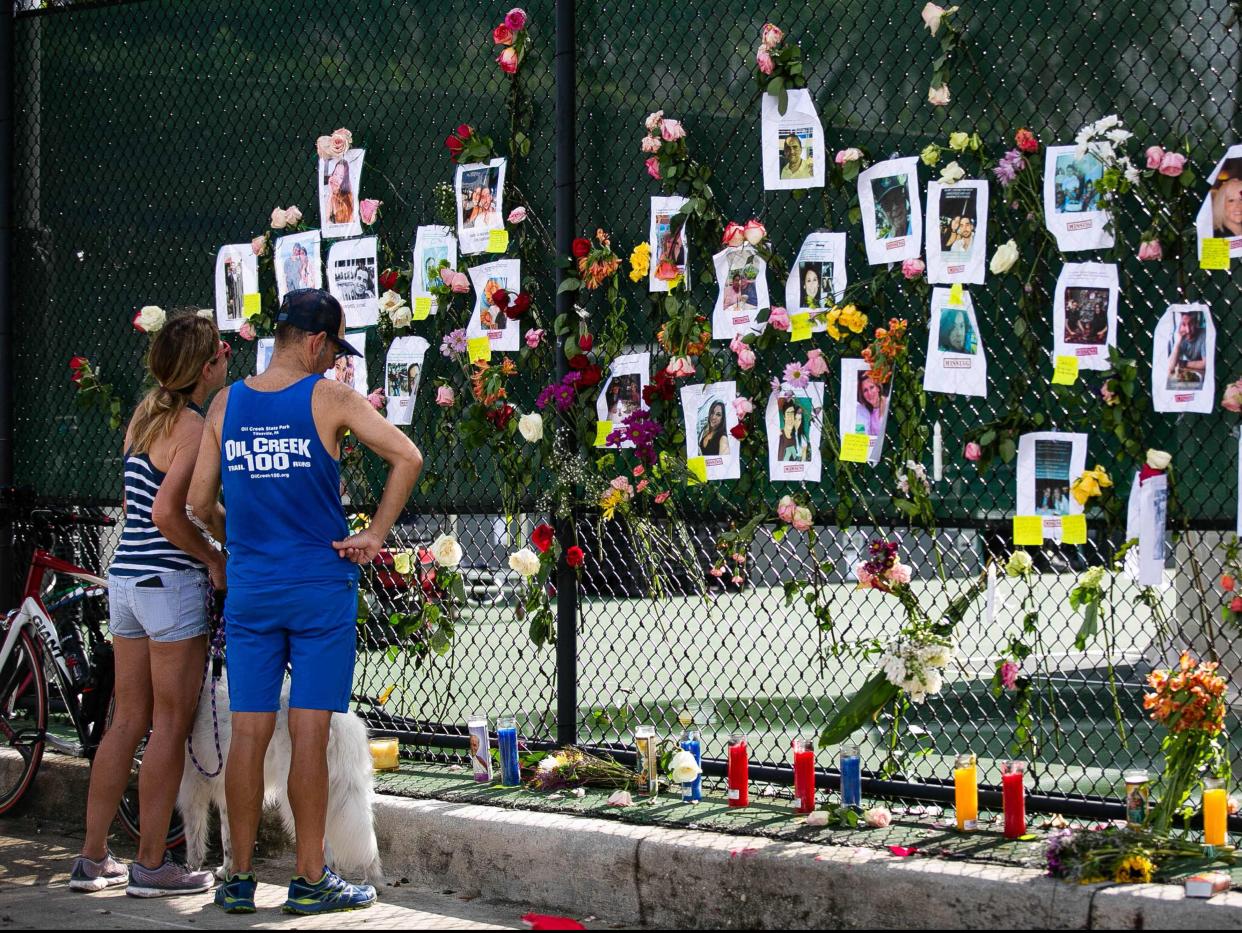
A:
[[1151, 304, 1216, 415]]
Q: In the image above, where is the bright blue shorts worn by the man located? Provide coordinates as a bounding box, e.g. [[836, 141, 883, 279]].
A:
[[225, 580, 358, 713]]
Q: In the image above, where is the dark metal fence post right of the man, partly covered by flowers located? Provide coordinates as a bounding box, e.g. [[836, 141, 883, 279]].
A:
[[553, 0, 578, 745]]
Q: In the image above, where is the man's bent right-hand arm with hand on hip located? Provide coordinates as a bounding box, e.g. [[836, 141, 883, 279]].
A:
[[322, 383, 422, 564]]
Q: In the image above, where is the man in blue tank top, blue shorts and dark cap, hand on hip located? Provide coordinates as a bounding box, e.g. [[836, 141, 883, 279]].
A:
[[189, 288, 422, 913]]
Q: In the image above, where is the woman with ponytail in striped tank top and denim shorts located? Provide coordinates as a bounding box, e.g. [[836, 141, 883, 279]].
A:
[[70, 314, 231, 897]]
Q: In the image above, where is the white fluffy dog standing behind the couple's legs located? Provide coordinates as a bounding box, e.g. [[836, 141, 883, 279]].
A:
[[176, 677, 384, 885]]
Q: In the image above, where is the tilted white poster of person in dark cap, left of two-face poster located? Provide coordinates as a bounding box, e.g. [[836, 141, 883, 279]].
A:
[[858, 155, 923, 266]]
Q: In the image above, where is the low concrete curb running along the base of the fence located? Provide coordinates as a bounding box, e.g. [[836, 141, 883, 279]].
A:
[[7, 755, 1242, 929]]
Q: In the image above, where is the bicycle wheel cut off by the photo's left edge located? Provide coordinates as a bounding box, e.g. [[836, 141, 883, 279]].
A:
[[0, 630, 47, 814]]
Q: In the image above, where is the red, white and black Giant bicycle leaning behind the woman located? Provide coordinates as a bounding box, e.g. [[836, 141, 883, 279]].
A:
[[0, 509, 185, 849]]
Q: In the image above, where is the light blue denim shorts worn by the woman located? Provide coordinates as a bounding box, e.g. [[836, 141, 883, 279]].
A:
[[108, 570, 207, 641]]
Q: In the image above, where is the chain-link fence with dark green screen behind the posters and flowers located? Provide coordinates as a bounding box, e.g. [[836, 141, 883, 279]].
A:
[[12, 0, 1242, 814]]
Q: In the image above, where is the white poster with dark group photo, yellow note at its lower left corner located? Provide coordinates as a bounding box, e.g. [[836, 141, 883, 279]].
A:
[[1052, 262, 1119, 369]]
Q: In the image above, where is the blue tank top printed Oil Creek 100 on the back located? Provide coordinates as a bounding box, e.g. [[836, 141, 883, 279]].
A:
[[220, 375, 358, 589]]
